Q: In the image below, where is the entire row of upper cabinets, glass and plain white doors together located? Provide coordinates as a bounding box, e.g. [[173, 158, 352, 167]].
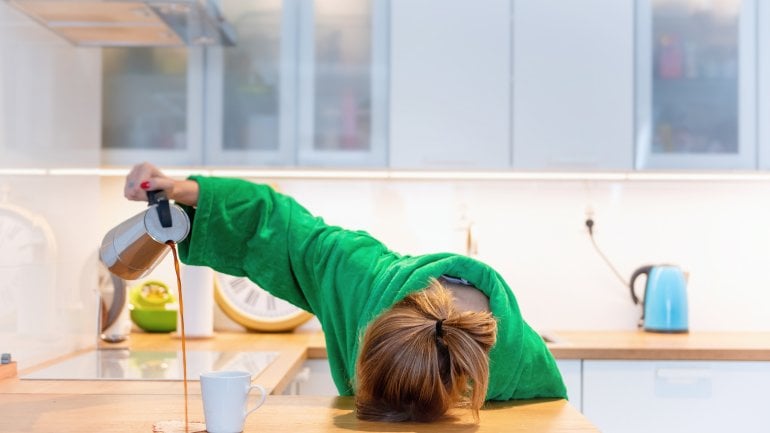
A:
[[102, 0, 770, 171]]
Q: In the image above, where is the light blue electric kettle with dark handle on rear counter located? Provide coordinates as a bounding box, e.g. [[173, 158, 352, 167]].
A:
[[629, 265, 688, 333]]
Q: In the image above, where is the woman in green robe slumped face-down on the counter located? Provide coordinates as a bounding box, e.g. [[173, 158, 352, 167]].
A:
[[124, 163, 566, 421]]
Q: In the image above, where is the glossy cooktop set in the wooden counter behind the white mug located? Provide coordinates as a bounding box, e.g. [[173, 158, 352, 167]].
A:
[[21, 349, 278, 381]]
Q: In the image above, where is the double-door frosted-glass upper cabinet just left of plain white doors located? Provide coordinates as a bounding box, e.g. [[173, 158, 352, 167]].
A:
[[204, 0, 387, 167]]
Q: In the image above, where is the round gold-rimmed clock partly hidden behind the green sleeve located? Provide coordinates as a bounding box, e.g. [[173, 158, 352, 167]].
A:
[[214, 272, 313, 331]]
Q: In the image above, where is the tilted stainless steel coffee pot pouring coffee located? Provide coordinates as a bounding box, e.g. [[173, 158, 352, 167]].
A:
[[99, 191, 190, 280]]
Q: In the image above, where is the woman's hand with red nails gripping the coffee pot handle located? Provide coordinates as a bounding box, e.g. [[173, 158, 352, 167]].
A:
[[123, 162, 198, 206]]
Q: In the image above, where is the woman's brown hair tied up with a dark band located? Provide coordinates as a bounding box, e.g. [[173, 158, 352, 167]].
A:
[[355, 279, 497, 422]]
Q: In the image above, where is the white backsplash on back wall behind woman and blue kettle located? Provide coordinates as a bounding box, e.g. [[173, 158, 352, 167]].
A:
[[101, 178, 770, 331]]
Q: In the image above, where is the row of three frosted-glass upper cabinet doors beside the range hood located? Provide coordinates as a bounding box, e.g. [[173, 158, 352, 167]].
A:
[[102, 0, 388, 166]]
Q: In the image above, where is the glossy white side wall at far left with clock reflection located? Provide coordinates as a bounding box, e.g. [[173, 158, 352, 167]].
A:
[[0, 2, 101, 368]]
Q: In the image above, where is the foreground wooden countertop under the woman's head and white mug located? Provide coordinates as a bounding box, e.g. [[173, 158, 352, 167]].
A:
[[0, 394, 599, 433]]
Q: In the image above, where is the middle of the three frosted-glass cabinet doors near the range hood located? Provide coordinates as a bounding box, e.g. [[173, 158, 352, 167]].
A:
[[204, 0, 299, 166]]
